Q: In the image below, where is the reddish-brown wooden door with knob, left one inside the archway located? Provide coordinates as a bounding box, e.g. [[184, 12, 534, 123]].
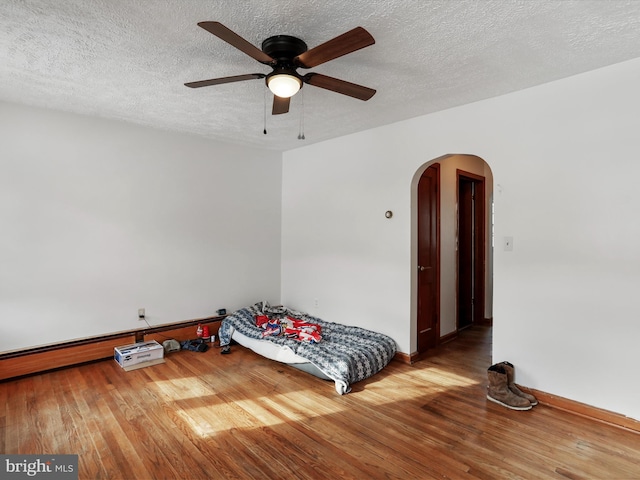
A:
[[415, 164, 440, 353]]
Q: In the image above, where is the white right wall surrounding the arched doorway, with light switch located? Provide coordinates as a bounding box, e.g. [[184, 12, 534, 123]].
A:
[[282, 59, 640, 419]]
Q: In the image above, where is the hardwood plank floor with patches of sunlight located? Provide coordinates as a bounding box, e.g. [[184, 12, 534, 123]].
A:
[[0, 327, 640, 479]]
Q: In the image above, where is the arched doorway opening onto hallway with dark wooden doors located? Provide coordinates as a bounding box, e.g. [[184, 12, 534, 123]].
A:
[[411, 155, 493, 358]]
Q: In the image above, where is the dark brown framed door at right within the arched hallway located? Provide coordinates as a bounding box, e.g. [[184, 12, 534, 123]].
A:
[[457, 170, 485, 330]]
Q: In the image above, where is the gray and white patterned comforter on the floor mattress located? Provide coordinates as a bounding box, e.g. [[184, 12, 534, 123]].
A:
[[218, 302, 396, 394]]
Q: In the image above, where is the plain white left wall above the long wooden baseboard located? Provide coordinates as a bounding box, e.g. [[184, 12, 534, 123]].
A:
[[0, 103, 282, 351]]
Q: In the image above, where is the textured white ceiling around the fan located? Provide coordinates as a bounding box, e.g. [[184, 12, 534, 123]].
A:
[[0, 0, 640, 150]]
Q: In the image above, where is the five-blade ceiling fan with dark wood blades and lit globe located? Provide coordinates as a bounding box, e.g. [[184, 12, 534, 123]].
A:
[[185, 22, 376, 115]]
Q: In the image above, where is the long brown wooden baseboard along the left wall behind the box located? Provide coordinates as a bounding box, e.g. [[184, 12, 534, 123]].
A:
[[0, 316, 224, 381]]
